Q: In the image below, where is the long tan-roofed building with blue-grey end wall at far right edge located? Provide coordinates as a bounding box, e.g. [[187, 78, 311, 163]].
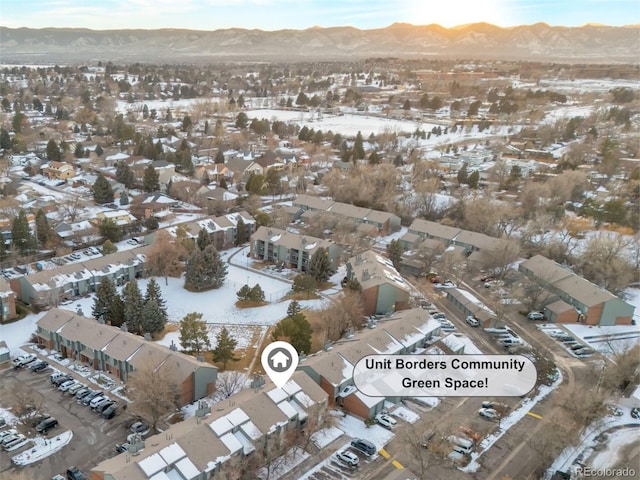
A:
[[518, 255, 634, 326]]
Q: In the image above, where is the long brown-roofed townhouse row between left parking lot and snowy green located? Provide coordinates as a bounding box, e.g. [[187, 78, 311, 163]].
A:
[[36, 308, 217, 405]]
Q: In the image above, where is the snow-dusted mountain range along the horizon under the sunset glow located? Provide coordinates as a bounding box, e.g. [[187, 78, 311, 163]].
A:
[[0, 23, 640, 64]]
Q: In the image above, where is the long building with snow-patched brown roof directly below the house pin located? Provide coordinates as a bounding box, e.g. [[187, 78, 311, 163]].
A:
[[91, 372, 327, 480]]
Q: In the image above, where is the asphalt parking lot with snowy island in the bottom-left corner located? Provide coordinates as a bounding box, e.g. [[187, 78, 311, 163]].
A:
[[0, 358, 135, 480]]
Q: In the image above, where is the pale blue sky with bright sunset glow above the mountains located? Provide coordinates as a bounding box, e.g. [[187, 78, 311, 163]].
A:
[[0, 0, 640, 30]]
